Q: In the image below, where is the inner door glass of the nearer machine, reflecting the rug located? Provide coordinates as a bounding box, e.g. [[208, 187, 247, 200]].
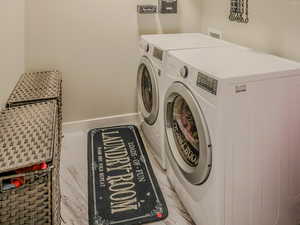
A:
[[172, 96, 200, 167]]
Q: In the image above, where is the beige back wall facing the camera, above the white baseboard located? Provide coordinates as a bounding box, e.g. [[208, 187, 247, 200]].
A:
[[26, 0, 200, 121]]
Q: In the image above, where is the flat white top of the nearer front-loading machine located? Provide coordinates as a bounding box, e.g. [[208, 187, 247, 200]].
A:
[[169, 47, 300, 79]]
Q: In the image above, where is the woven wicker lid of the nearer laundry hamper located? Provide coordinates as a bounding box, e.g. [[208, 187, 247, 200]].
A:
[[0, 100, 58, 173]]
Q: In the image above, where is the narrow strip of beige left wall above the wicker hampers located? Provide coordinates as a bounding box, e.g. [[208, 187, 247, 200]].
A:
[[0, 0, 24, 105]]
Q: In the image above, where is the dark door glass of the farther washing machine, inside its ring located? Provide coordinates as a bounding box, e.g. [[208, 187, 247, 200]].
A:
[[141, 66, 153, 113]]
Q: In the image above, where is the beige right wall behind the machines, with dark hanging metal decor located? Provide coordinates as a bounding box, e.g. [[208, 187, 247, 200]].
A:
[[200, 0, 300, 61]]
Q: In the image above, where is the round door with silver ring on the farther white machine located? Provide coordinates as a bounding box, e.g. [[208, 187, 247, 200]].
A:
[[137, 57, 159, 125]]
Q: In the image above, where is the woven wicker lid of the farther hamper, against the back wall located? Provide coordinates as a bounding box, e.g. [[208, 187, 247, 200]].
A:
[[7, 70, 62, 107]]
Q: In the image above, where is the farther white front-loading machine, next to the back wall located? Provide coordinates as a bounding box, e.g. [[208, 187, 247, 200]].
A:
[[137, 33, 241, 168]]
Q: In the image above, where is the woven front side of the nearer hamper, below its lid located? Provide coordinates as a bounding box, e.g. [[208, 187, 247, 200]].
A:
[[0, 168, 52, 225]]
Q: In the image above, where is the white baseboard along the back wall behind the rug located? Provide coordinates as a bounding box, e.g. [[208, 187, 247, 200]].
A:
[[62, 113, 140, 133]]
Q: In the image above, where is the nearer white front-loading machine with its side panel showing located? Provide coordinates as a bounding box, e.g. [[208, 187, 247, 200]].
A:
[[164, 47, 300, 225]]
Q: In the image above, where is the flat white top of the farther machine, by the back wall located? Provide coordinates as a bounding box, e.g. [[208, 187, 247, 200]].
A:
[[141, 33, 236, 51]]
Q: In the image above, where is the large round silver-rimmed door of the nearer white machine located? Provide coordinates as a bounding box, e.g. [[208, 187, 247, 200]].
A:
[[165, 82, 212, 185]]
